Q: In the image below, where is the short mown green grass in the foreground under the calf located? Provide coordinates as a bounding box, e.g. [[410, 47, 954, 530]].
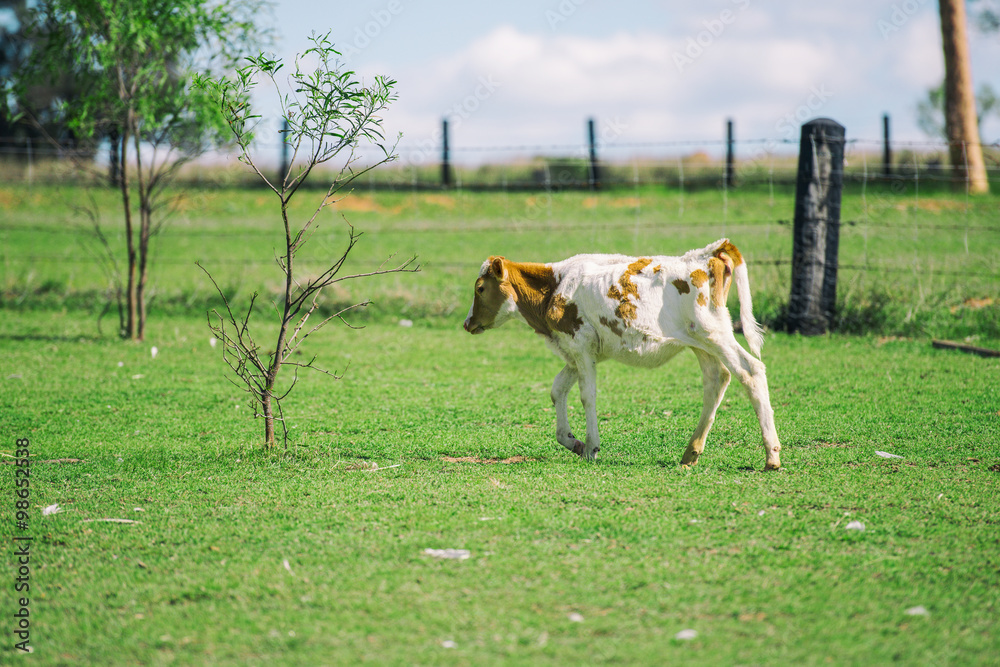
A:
[[0, 310, 1000, 665]]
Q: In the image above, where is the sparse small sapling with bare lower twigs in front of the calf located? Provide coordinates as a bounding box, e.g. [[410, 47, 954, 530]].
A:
[[200, 35, 419, 448]]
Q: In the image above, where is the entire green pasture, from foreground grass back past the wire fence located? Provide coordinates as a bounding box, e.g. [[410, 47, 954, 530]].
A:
[[0, 180, 1000, 665]]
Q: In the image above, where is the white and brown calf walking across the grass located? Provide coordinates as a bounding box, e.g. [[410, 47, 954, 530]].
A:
[[465, 239, 781, 470]]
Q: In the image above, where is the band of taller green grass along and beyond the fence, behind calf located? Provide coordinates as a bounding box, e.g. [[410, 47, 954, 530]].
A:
[[0, 181, 1000, 346]]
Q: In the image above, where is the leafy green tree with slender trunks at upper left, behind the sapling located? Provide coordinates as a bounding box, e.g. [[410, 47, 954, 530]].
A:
[[13, 0, 263, 340]]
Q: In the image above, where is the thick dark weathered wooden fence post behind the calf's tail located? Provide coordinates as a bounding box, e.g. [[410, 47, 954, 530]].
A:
[[788, 118, 846, 336]]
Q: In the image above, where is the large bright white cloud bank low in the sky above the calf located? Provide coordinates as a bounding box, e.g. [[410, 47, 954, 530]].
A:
[[382, 26, 860, 157]]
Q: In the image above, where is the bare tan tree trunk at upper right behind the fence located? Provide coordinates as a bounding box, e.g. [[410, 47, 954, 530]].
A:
[[939, 0, 990, 194]]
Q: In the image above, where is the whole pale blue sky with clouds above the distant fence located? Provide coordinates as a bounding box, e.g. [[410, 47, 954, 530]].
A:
[[250, 0, 1000, 163]]
